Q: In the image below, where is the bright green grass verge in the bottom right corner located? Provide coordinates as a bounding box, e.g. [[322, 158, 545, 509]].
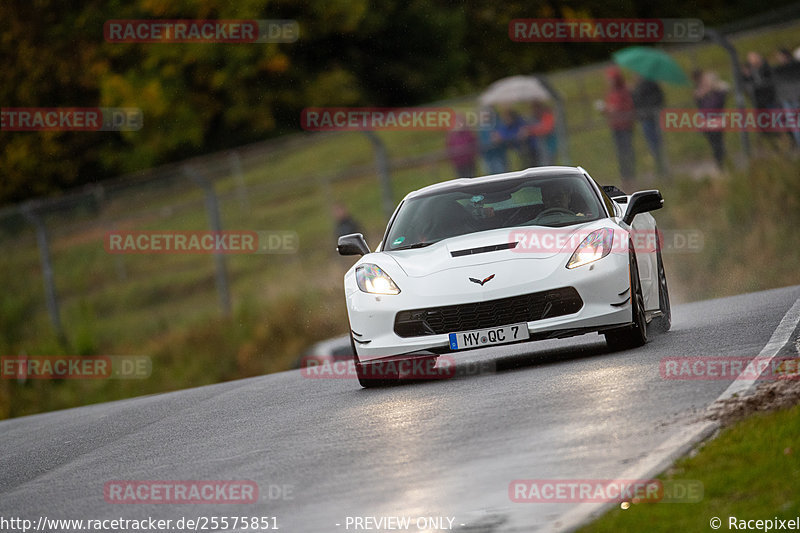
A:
[[579, 406, 800, 533]]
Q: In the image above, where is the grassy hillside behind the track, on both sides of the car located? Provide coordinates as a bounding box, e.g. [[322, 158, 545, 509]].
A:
[[0, 22, 800, 418]]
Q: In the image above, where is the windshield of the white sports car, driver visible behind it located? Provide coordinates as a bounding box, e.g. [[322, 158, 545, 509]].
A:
[[384, 174, 604, 251]]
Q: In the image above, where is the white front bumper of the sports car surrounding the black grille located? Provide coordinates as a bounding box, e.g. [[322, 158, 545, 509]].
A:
[[345, 253, 631, 362]]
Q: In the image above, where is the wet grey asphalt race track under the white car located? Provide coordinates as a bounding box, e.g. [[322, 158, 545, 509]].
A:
[[0, 286, 800, 532]]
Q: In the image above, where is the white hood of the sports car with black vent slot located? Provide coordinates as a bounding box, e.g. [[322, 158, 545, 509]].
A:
[[381, 220, 608, 277]]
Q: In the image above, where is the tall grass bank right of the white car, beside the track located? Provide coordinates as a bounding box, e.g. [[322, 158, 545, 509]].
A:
[[655, 156, 800, 300]]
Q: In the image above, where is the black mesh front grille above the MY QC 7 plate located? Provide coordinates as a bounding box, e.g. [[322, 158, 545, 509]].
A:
[[394, 287, 583, 337]]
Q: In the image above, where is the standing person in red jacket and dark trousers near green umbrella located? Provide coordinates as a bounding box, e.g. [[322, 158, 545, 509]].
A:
[[601, 67, 636, 187]]
